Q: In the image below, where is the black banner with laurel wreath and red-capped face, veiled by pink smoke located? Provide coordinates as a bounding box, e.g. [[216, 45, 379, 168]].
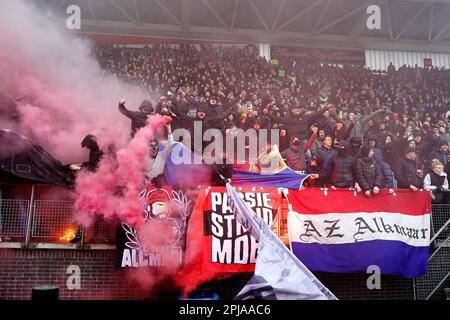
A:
[[116, 185, 192, 268]]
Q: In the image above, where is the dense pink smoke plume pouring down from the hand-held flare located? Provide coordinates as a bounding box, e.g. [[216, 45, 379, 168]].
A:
[[75, 115, 170, 227]]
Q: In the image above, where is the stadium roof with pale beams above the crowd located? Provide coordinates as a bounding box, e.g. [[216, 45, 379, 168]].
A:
[[37, 0, 450, 52]]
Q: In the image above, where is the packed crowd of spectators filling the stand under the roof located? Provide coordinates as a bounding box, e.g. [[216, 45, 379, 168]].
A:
[[97, 45, 450, 203]]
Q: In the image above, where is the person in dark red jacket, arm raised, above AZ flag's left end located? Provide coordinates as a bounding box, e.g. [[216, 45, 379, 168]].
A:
[[281, 127, 318, 171]]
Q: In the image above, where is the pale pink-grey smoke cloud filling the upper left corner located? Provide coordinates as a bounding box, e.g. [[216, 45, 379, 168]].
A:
[[0, 0, 145, 163]]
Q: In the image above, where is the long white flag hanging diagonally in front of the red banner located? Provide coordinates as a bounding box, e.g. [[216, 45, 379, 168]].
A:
[[227, 184, 337, 300]]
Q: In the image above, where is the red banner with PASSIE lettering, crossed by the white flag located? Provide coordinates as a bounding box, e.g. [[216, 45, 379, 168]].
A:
[[186, 187, 281, 273]]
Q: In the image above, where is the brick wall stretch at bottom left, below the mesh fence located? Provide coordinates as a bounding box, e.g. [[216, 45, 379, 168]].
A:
[[0, 249, 168, 299]]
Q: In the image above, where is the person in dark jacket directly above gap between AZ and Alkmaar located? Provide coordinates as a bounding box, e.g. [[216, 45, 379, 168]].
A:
[[326, 140, 355, 188]]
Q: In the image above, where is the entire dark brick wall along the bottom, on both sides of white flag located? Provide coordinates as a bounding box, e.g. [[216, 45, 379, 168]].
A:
[[0, 249, 414, 300]]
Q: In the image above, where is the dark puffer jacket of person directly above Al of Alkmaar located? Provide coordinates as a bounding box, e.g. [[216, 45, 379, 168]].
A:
[[356, 157, 383, 191]]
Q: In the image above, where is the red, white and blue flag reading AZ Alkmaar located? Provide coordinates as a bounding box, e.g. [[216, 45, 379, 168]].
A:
[[288, 190, 431, 278]]
